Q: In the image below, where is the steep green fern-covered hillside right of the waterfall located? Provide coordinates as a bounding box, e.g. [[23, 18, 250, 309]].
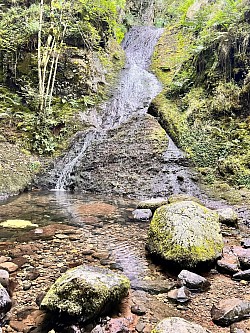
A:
[[150, 0, 250, 195]]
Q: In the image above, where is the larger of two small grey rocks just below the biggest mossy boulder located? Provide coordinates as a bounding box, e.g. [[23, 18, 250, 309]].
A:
[[177, 270, 210, 291]]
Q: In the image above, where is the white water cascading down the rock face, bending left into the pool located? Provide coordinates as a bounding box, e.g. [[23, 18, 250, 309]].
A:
[[53, 27, 163, 190]]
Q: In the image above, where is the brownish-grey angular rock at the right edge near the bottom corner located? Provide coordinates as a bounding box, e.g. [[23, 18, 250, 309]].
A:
[[211, 298, 250, 326]]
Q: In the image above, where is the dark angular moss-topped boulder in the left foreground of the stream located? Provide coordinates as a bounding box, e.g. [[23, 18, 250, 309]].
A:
[[40, 266, 130, 322]]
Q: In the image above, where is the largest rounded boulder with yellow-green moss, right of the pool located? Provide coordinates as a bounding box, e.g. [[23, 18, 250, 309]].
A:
[[147, 201, 223, 267]]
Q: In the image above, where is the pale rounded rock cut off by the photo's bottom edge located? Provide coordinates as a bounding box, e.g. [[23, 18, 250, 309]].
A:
[[151, 317, 209, 333]]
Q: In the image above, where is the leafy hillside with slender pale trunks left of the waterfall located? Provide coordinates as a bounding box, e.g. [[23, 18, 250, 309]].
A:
[[0, 0, 125, 154]]
